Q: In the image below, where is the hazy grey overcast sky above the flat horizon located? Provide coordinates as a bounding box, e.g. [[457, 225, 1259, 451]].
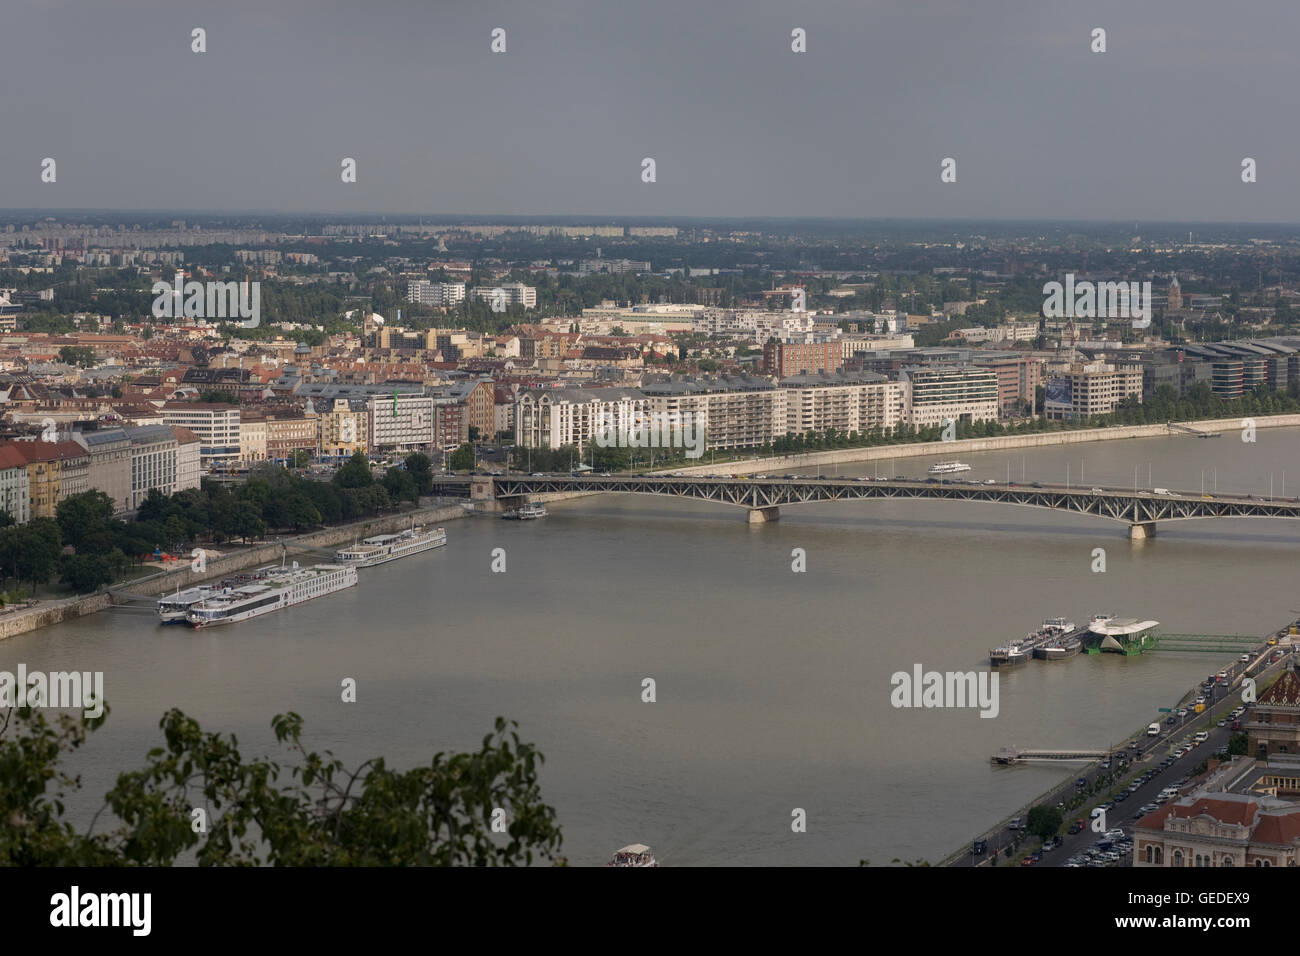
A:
[[0, 0, 1300, 221]]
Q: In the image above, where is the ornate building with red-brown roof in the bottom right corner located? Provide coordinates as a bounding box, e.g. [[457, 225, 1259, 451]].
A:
[[1134, 791, 1300, 868]]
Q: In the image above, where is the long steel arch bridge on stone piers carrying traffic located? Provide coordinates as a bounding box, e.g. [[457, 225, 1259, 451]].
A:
[[433, 475, 1300, 538]]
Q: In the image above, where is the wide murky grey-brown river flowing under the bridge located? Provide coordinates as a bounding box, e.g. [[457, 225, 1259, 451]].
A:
[[0, 428, 1300, 865]]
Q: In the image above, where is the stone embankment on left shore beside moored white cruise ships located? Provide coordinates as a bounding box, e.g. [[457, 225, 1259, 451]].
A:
[[0, 503, 465, 640]]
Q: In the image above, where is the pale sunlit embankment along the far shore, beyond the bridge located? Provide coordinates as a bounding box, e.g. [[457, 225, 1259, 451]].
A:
[[660, 415, 1300, 475]]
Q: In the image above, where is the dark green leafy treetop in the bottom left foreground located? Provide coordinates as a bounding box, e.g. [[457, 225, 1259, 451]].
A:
[[0, 708, 564, 866]]
